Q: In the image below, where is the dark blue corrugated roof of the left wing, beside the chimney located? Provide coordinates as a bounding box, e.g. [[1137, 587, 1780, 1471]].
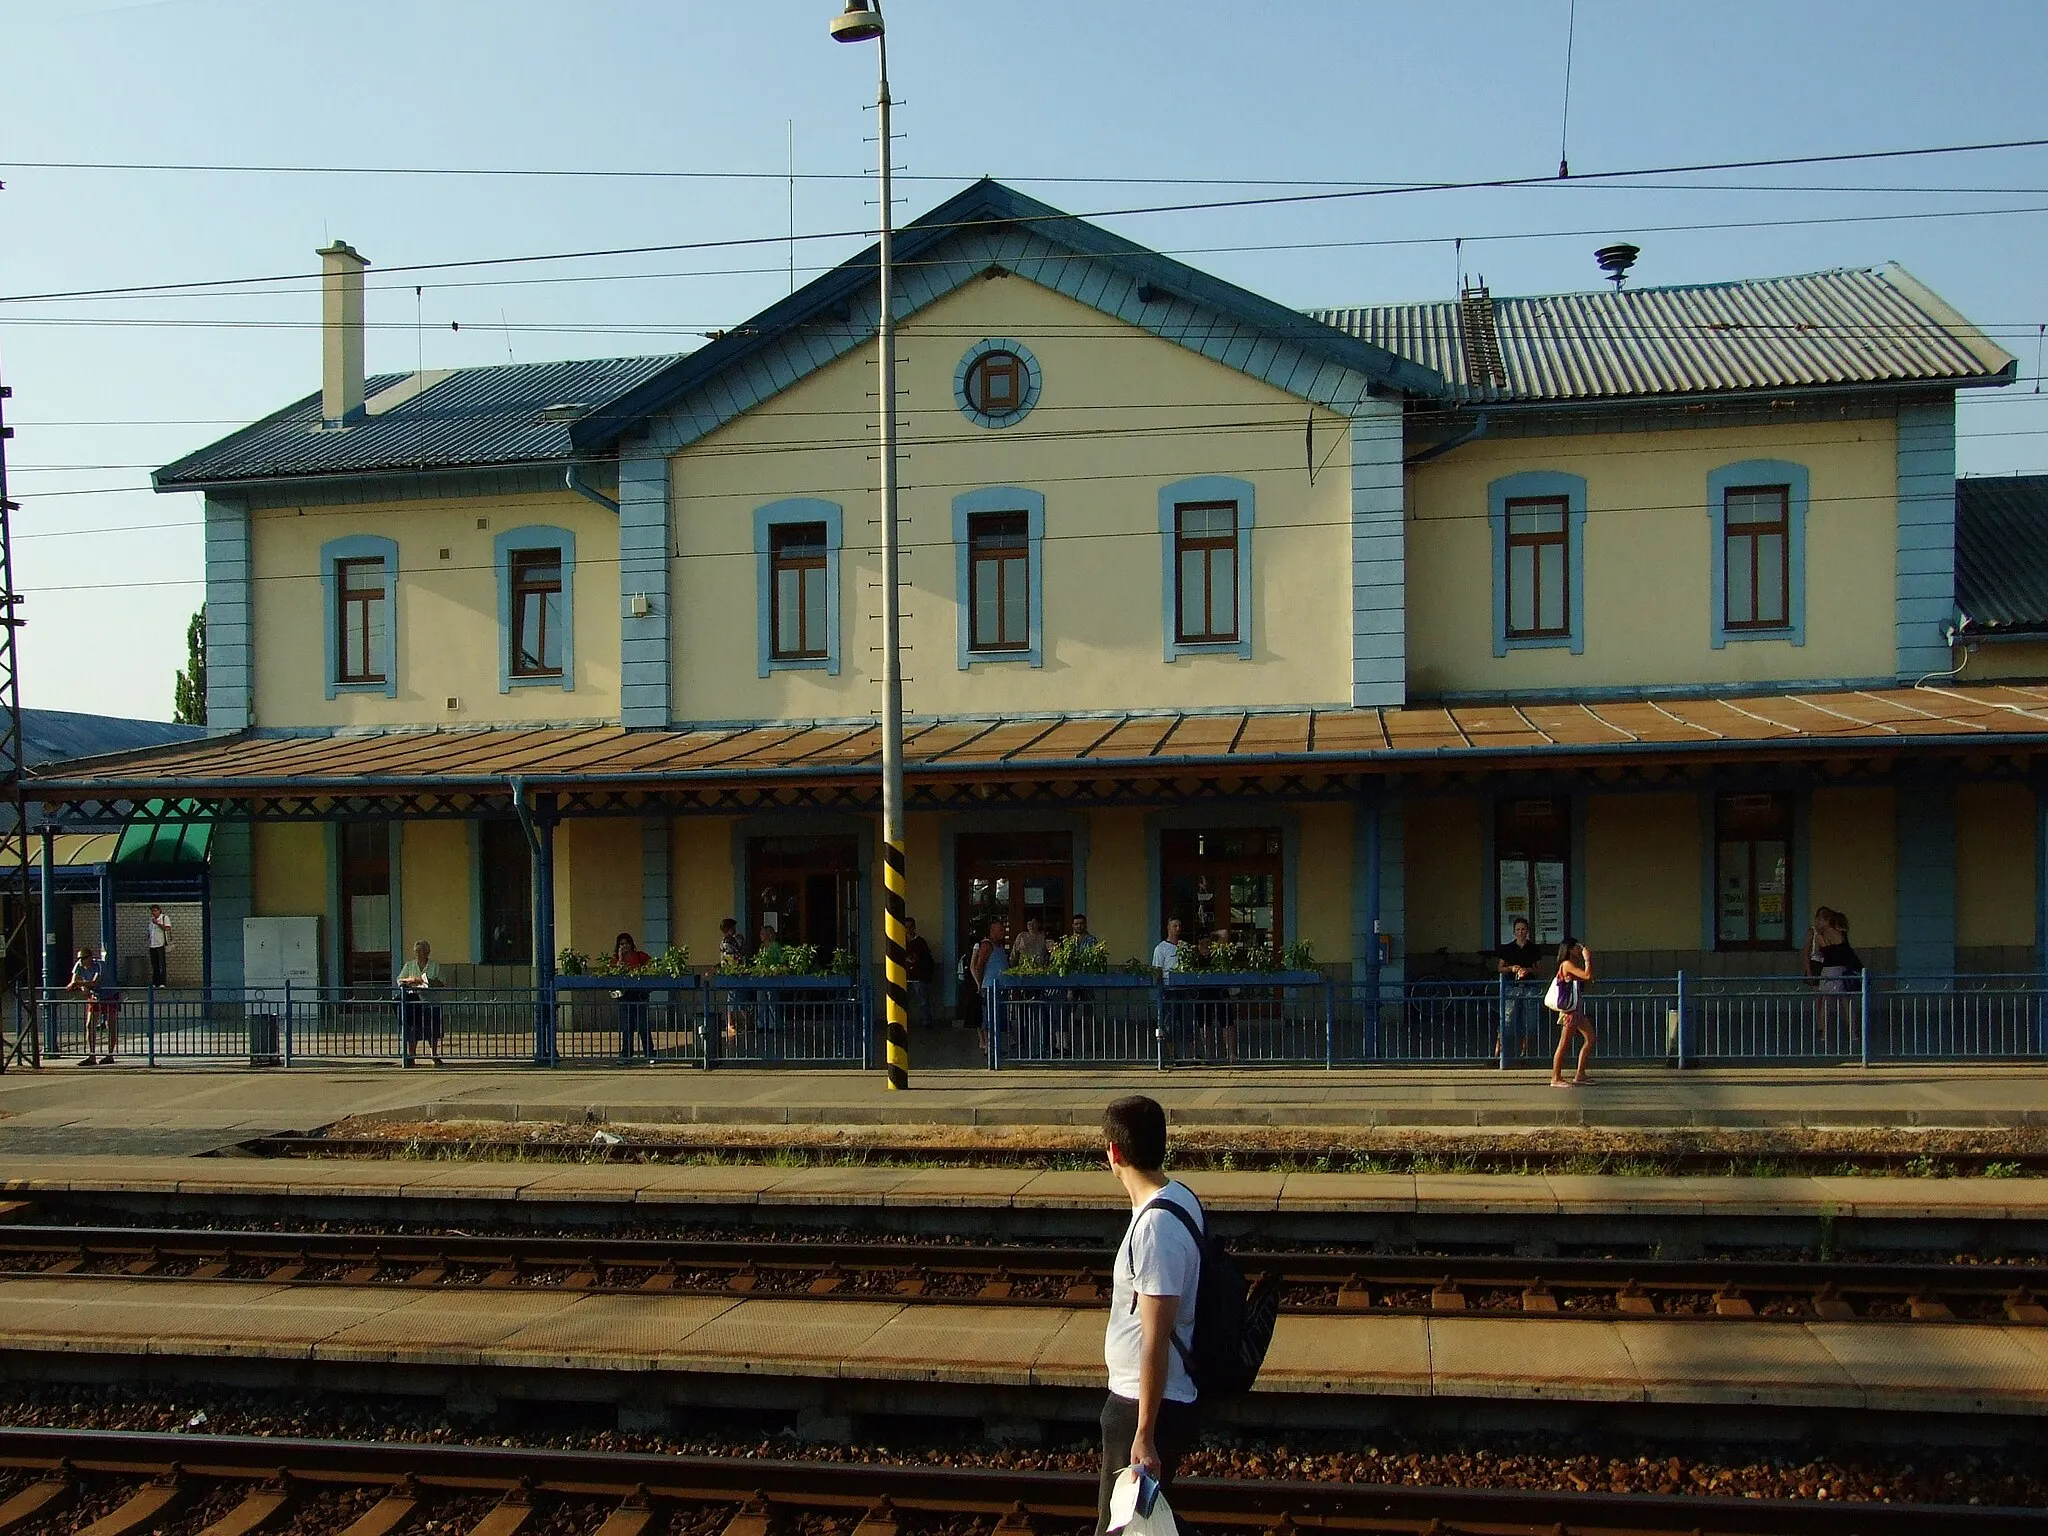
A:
[[156, 354, 676, 492]]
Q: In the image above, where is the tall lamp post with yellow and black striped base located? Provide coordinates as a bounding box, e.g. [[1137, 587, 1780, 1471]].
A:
[[831, 0, 909, 1087]]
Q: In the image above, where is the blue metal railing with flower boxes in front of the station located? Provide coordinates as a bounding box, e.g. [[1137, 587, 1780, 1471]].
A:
[[37, 973, 2048, 1069]]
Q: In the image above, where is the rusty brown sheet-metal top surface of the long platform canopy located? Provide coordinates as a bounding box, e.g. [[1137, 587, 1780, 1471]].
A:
[[29, 684, 2048, 805]]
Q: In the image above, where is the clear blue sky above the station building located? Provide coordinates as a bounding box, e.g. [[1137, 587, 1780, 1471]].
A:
[[0, 0, 2048, 717]]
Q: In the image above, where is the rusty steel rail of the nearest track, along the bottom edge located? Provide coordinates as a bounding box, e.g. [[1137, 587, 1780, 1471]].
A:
[[0, 1427, 2044, 1536]]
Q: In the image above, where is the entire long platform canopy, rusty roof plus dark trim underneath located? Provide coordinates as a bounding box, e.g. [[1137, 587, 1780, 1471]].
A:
[[27, 684, 2048, 831]]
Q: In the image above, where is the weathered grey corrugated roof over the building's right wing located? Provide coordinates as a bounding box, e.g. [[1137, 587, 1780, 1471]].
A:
[[1309, 264, 2013, 401]]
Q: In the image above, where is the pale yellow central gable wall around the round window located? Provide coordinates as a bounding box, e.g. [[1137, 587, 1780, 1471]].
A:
[[672, 276, 1352, 721]]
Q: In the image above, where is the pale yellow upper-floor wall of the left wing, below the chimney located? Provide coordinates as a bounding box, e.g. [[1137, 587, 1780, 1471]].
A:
[[250, 492, 618, 729]]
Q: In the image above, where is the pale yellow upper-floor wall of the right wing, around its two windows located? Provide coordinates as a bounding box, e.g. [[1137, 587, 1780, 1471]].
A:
[[1407, 418, 1898, 694]]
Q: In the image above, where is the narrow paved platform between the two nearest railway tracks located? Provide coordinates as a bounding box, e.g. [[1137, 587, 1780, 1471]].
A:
[[0, 1278, 2048, 1419]]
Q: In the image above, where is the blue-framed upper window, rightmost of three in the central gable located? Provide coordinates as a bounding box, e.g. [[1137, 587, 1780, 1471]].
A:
[[1159, 475, 1257, 662]]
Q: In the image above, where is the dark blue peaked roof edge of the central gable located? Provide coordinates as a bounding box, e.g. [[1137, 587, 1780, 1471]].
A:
[[569, 178, 1444, 453]]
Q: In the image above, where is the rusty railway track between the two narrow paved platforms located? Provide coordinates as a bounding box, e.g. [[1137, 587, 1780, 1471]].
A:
[[0, 1225, 2048, 1327]]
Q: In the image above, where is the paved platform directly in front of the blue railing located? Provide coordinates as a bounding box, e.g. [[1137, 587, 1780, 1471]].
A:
[[0, 1065, 2048, 1153]]
